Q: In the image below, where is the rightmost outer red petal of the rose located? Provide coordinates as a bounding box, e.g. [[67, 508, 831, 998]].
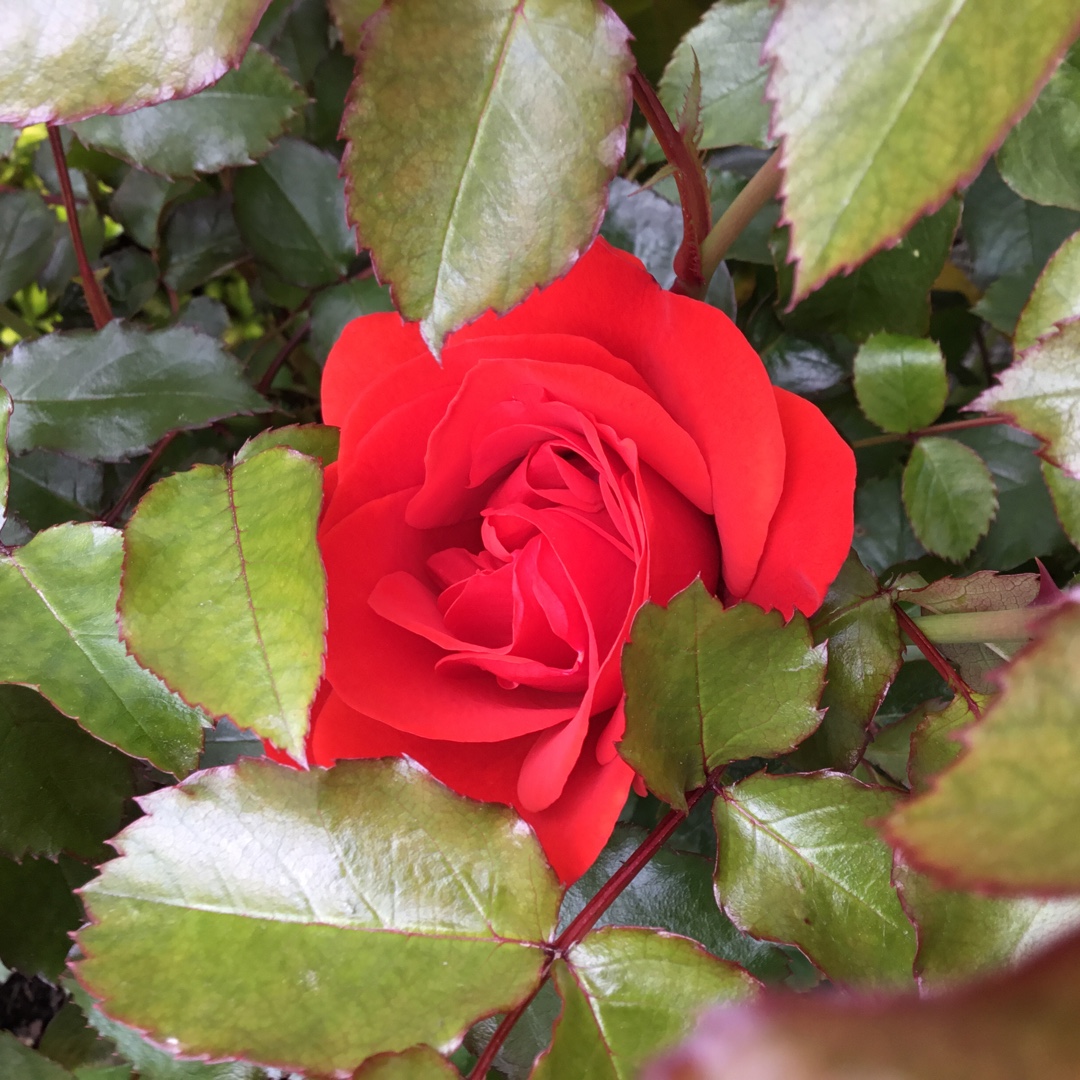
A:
[[745, 388, 855, 619]]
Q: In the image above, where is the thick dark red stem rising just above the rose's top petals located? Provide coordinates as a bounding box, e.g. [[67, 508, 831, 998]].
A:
[[631, 68, 713, 299]]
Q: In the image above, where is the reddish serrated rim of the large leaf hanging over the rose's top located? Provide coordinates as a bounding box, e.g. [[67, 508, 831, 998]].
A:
[[336, 0, 635, 354]]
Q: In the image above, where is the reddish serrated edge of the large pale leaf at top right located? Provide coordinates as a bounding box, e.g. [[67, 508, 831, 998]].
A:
[[761, 7, 1080, 304]]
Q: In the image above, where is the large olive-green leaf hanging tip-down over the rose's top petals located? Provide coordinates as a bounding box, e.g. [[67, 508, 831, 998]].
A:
[[343, 0, 632, 350]]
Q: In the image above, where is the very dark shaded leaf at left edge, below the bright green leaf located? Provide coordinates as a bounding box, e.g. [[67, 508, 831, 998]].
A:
[[0, 685, 134, 862]]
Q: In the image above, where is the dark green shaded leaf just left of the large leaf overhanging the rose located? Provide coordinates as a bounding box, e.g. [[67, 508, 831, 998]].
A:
[[233, 138, 354, 286]]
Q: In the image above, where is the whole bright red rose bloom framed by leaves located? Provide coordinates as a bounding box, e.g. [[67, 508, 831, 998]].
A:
[[276, 240, 854, 881]]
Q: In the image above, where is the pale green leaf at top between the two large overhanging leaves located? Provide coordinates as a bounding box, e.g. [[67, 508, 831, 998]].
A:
[[659, 0, 775, 149]]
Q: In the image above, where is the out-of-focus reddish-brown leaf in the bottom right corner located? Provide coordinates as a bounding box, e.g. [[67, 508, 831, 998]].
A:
[[644, 936, 1080, 1080]]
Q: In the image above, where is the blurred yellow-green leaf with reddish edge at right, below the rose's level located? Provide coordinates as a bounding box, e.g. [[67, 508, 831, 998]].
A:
[[889, 604, 1080, 894]]
